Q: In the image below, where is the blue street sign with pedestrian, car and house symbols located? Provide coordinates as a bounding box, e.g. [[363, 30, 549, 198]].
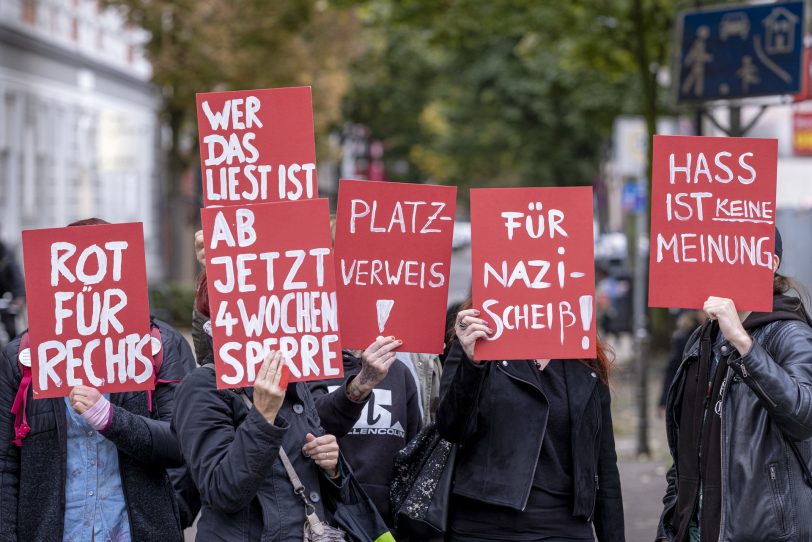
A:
[[676, 2, 804, 103]]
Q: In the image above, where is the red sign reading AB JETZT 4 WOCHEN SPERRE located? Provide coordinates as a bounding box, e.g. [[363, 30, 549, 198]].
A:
[[201, 199, 344, 389]]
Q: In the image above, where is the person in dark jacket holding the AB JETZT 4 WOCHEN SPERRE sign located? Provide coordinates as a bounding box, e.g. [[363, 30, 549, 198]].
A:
[[173, 266, 393, 542]]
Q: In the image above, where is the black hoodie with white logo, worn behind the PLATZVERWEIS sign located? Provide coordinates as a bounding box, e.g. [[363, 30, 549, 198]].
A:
[[314, 351, 422, 525]]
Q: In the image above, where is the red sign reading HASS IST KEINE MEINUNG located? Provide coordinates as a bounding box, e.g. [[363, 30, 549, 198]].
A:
[[648, 136, 778, 311]]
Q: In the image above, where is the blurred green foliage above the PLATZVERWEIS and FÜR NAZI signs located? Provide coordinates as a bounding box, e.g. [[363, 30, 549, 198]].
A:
[[345, 0, 676, 192]]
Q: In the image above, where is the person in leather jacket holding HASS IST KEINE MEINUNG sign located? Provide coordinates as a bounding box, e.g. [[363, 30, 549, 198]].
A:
[[657, 230, 812, 542]]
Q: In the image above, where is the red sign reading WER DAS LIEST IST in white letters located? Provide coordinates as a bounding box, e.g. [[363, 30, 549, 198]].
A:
[[197, 87, 317, 206]]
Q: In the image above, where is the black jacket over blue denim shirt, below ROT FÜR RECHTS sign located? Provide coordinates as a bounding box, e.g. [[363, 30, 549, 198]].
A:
[[0, 322, 191, 542]]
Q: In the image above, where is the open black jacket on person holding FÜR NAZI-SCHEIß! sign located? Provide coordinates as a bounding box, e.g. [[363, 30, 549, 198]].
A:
[[437, 341, 625, 542]]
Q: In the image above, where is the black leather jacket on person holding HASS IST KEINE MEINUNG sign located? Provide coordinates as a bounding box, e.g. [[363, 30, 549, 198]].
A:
[[657, 320, 812, 542]]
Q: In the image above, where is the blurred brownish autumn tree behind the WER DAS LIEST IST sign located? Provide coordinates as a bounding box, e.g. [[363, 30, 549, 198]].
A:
[[101, 0, 358, 279]]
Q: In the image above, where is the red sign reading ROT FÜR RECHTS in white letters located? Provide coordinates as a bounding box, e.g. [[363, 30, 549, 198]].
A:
[[23, 223, 154, 398]]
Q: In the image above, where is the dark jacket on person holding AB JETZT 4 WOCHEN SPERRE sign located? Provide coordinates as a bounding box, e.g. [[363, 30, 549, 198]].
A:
[[172, 367, 366, 542]]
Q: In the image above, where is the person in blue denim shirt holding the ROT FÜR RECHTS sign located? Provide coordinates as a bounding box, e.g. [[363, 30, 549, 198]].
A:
[[0, 219, 194, 541]]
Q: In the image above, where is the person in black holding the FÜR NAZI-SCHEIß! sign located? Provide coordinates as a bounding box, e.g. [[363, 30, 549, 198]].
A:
[[437, 309, 625, 542]]
